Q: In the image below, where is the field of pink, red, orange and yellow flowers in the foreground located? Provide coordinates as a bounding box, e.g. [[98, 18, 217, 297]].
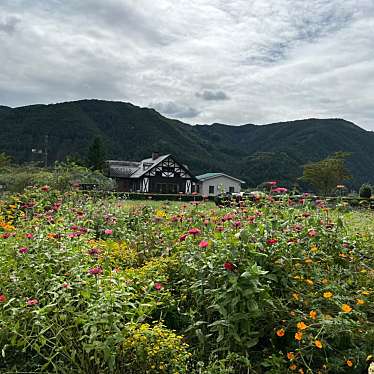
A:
[[0, 186, 374, 374]]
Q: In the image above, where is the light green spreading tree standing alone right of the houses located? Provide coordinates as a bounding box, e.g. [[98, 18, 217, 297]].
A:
[[300, 152, 352, 196]]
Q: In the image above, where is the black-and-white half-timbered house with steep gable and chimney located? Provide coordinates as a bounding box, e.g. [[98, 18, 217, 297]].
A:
[[107, 152, 198, 194]]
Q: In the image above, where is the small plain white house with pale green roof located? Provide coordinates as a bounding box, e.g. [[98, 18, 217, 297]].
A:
[[196, 173, 245, 196]]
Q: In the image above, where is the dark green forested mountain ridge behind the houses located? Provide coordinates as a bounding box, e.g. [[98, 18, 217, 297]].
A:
[[0, 100, 374, 186]]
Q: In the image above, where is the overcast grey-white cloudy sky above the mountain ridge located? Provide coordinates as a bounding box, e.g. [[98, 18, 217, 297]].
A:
[[0, 0, 374, 130]]
